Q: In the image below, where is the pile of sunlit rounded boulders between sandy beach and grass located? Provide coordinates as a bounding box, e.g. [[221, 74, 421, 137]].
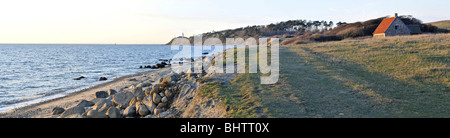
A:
[[52, 73, 182, 118]]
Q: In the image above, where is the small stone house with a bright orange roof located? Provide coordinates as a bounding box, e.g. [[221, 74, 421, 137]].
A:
[[373, 13, 421, 37]]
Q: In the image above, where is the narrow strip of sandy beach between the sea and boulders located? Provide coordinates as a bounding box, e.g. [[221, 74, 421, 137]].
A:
[[0, 68, 171, 118]]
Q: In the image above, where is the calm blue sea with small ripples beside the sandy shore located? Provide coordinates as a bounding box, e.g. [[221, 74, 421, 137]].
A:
[[0, 44, 186, 112]]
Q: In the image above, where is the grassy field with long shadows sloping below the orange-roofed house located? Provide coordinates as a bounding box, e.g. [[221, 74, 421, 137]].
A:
[[201, 34, 450, 118]]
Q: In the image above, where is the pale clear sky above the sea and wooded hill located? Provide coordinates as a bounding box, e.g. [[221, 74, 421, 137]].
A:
[[0, 0, 450, 44]]
